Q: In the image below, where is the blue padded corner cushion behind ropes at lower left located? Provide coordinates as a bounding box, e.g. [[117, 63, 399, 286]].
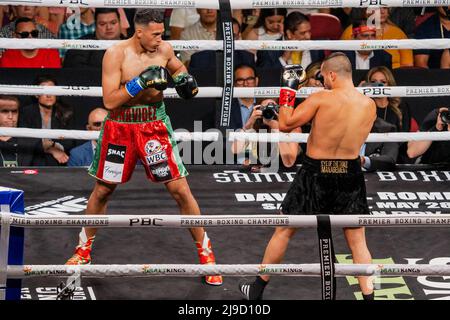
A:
[[0, 186, 25, 300]]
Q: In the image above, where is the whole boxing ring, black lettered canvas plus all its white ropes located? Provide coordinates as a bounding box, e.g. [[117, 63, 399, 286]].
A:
[[0, 0, 450, 300]]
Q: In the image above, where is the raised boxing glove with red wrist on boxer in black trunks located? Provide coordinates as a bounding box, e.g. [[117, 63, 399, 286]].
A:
[[278, 64, 308, 108]]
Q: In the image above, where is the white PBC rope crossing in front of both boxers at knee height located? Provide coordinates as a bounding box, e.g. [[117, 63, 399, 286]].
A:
[[0, 212, 450, 228]]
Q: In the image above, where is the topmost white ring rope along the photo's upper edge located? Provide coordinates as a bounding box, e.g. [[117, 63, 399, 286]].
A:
[[4, 0, 450, 9]]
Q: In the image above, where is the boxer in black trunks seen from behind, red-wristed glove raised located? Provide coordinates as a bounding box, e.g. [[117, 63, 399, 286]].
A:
[[239, 53, 376, 300]]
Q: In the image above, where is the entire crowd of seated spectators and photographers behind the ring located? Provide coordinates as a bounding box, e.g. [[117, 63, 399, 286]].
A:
[[0, 5, 450, 170]]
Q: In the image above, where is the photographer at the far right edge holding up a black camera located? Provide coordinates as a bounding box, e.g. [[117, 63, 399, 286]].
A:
[[407, 107, 450, 164]]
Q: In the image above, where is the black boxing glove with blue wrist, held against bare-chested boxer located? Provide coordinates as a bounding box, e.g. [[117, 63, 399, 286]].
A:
[[125, 66, 167, 97]]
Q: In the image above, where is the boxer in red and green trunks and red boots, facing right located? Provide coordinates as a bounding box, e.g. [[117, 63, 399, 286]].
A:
[[66, 9, 222, 285]]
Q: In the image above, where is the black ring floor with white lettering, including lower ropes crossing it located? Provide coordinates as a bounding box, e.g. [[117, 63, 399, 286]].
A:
[[0, 166, 450, 300]]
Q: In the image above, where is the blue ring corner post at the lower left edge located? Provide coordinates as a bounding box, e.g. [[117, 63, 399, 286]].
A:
[[0, 187, 24, 300]]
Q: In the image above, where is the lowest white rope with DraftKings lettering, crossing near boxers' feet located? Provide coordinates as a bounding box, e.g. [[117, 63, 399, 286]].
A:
[[7, 263, 450, 279]]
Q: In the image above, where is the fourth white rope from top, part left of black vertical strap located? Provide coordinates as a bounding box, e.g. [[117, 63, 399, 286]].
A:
[[0, 127, 219, 141]]
